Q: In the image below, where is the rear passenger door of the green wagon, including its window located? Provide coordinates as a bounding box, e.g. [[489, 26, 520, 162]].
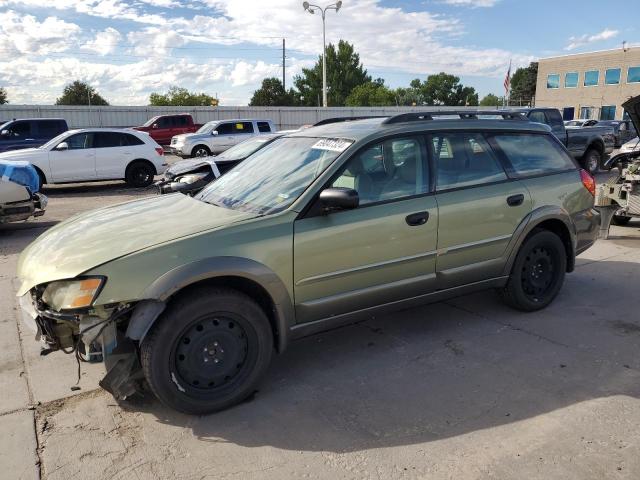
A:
[[429, 131, 532, 288]]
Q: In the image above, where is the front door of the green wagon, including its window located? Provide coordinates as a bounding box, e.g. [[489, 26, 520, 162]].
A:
[[294, 137, 438, 322]]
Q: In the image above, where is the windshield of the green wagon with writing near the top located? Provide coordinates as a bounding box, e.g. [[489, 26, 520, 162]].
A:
[[195, 137, 352, 215]]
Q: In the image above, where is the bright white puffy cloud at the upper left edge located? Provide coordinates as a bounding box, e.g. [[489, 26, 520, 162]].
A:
[[0, 10, 81, 56]]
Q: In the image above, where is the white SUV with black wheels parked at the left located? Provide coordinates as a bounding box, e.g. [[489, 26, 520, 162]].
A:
[[0, 128, 168, 187]]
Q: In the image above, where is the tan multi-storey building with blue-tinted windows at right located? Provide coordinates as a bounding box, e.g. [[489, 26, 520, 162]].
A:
[[535, 47, 640, 120]]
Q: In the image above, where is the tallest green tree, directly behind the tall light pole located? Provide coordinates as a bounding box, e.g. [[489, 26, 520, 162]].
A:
[[293, 40, 371, 106]]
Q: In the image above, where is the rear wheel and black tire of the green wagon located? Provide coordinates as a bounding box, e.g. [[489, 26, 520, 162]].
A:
[[500, 229, 567, 312]]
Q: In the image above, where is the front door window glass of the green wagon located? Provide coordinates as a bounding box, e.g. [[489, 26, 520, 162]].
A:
[[331, 138, 429, 205]]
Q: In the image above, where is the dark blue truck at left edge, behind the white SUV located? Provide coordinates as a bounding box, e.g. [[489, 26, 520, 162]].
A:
[[0, 118, 69, 153]]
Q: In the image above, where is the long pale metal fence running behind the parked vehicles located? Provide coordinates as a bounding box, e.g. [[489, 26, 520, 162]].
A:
[[0, 104, 498, 130]]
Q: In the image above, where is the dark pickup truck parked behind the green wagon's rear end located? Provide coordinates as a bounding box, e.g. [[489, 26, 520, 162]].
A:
[[517, 108, 615, 174]]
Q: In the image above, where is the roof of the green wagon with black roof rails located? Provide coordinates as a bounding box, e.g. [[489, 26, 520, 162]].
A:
[[287, 116, 549, 141]]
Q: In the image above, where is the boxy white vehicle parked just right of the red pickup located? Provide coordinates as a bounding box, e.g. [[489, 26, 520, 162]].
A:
[[170, 119, 276, 157]]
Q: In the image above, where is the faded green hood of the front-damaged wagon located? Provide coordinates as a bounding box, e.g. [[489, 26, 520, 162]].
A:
[[18, 193, 256, 295]]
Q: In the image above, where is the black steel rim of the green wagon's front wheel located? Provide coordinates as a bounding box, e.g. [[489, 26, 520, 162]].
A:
[[172, 315, 249, 393]]
